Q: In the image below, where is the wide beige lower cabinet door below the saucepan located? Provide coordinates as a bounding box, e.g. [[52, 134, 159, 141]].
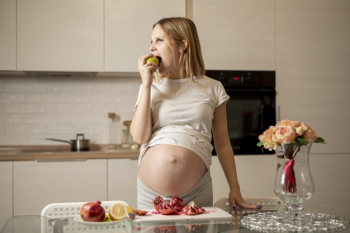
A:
[[13, 159, 107, 216]]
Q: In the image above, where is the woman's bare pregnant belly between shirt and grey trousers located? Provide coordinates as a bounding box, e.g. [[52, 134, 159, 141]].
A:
[[139, 145, 207, 196]]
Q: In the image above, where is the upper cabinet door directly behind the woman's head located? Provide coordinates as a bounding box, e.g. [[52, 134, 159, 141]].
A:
[[105, 0, 186, 72]]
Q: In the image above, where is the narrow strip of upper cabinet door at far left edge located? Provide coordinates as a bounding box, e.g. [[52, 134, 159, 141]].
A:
[[0, 0, 16, 71]]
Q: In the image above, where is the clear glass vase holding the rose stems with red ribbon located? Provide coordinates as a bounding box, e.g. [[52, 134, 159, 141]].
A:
[[274, 142, 315, 221]]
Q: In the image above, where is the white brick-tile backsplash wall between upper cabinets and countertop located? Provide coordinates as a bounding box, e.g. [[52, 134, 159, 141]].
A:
[[0, 74, 141, 145]]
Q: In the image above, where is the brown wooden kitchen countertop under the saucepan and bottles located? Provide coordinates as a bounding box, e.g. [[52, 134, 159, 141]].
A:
[[0, 144, 139, 161]]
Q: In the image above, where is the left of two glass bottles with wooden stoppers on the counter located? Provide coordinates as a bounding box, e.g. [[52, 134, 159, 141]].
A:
[[107, 113, 122, 149]]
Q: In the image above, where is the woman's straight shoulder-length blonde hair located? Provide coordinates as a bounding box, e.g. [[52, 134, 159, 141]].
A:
[[153, 17, 205, 82]]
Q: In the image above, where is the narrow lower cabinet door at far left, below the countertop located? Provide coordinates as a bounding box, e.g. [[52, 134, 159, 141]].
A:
[[0, 162, 13, 229]]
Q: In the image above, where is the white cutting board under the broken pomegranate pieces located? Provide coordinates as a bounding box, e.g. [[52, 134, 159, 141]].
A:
[[134, 207, 232, 222]]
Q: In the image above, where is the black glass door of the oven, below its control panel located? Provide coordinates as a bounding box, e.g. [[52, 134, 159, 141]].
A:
[[213, 89, 276, 155]]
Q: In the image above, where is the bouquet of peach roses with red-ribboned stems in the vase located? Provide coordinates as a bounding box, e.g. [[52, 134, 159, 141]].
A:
[[256, 119, 324, 193]]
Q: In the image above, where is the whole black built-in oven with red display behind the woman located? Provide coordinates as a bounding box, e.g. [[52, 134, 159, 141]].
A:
[[206, 70, 276, 155]]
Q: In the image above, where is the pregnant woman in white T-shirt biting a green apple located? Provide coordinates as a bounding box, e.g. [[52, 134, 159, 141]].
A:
[[130, 18, 260, 209]]
